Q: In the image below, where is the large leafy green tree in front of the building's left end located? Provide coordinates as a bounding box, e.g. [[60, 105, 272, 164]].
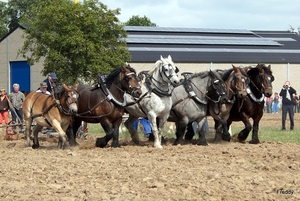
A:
[[19, 0, 130, 83]]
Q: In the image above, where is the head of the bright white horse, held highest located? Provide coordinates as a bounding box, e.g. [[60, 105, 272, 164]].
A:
[[149, 55, 180, 86]]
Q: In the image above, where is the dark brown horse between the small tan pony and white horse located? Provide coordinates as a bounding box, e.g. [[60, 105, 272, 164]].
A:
[[67, 66, 142, 147]]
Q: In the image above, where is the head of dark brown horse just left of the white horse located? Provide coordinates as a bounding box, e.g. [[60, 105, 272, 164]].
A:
[[119, 65, 142, 98]]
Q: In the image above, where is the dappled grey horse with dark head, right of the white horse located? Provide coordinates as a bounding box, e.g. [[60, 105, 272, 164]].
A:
[[168, 71, 225, 145]]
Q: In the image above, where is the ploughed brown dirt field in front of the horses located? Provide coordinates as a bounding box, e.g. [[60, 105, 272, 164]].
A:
[[0, 115, 300, 200]]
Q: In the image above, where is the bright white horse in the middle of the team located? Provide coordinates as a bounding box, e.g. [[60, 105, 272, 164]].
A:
[[125, 55, 180, 148]]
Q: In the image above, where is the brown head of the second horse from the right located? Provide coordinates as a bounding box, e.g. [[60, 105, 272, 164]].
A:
[[230, 65, 250, 98]]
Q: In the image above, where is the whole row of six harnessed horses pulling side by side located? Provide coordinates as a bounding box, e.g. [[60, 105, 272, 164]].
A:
[[23, 56, 274, 148]]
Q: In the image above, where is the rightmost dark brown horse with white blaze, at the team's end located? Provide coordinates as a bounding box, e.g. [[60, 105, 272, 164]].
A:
[[227, 64, 274, 144]]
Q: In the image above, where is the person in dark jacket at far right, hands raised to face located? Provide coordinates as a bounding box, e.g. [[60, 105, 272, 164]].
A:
[[279, 81, 296, 130]]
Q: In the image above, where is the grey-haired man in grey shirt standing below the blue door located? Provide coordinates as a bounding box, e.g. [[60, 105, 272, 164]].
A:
[[9, 83, 25, 134]]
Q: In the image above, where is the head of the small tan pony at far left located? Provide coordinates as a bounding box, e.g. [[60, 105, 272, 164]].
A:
[[61, 84, 79, 115]]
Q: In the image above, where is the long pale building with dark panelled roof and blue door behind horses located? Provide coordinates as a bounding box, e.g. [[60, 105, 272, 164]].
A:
[[0, 26, 300, 92]]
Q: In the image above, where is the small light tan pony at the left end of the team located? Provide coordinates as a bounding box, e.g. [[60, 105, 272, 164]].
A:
[[22, 84, 79, 149]]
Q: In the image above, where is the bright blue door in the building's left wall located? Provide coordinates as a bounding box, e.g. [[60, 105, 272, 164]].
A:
[[10, 61, 30, 93]]
